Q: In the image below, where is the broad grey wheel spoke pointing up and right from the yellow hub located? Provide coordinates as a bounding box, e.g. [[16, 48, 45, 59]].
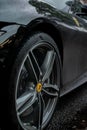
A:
[[41, 51, 55, 82]]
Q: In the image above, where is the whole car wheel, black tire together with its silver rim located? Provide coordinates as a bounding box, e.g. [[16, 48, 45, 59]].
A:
[[2, 32, 60, 130]]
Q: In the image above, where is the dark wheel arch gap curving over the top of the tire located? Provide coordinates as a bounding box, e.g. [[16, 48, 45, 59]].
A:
[[2, 18, 63, 66]]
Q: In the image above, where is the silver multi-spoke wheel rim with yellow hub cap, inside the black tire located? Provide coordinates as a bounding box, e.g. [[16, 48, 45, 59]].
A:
[[15, 43, 59, 130]]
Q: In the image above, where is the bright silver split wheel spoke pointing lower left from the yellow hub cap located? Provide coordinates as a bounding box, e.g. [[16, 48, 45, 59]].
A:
[[16, 92, 36, 116]]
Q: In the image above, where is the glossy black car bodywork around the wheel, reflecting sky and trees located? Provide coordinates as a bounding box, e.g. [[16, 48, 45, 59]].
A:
[[0, 0, 87, 95]]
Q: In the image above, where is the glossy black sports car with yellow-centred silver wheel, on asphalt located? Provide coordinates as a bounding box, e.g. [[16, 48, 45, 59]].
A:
[[0, 0, 87, 130]]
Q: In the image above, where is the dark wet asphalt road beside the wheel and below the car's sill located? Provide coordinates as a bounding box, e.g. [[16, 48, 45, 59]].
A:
[[46, 84, 87, 130]]
